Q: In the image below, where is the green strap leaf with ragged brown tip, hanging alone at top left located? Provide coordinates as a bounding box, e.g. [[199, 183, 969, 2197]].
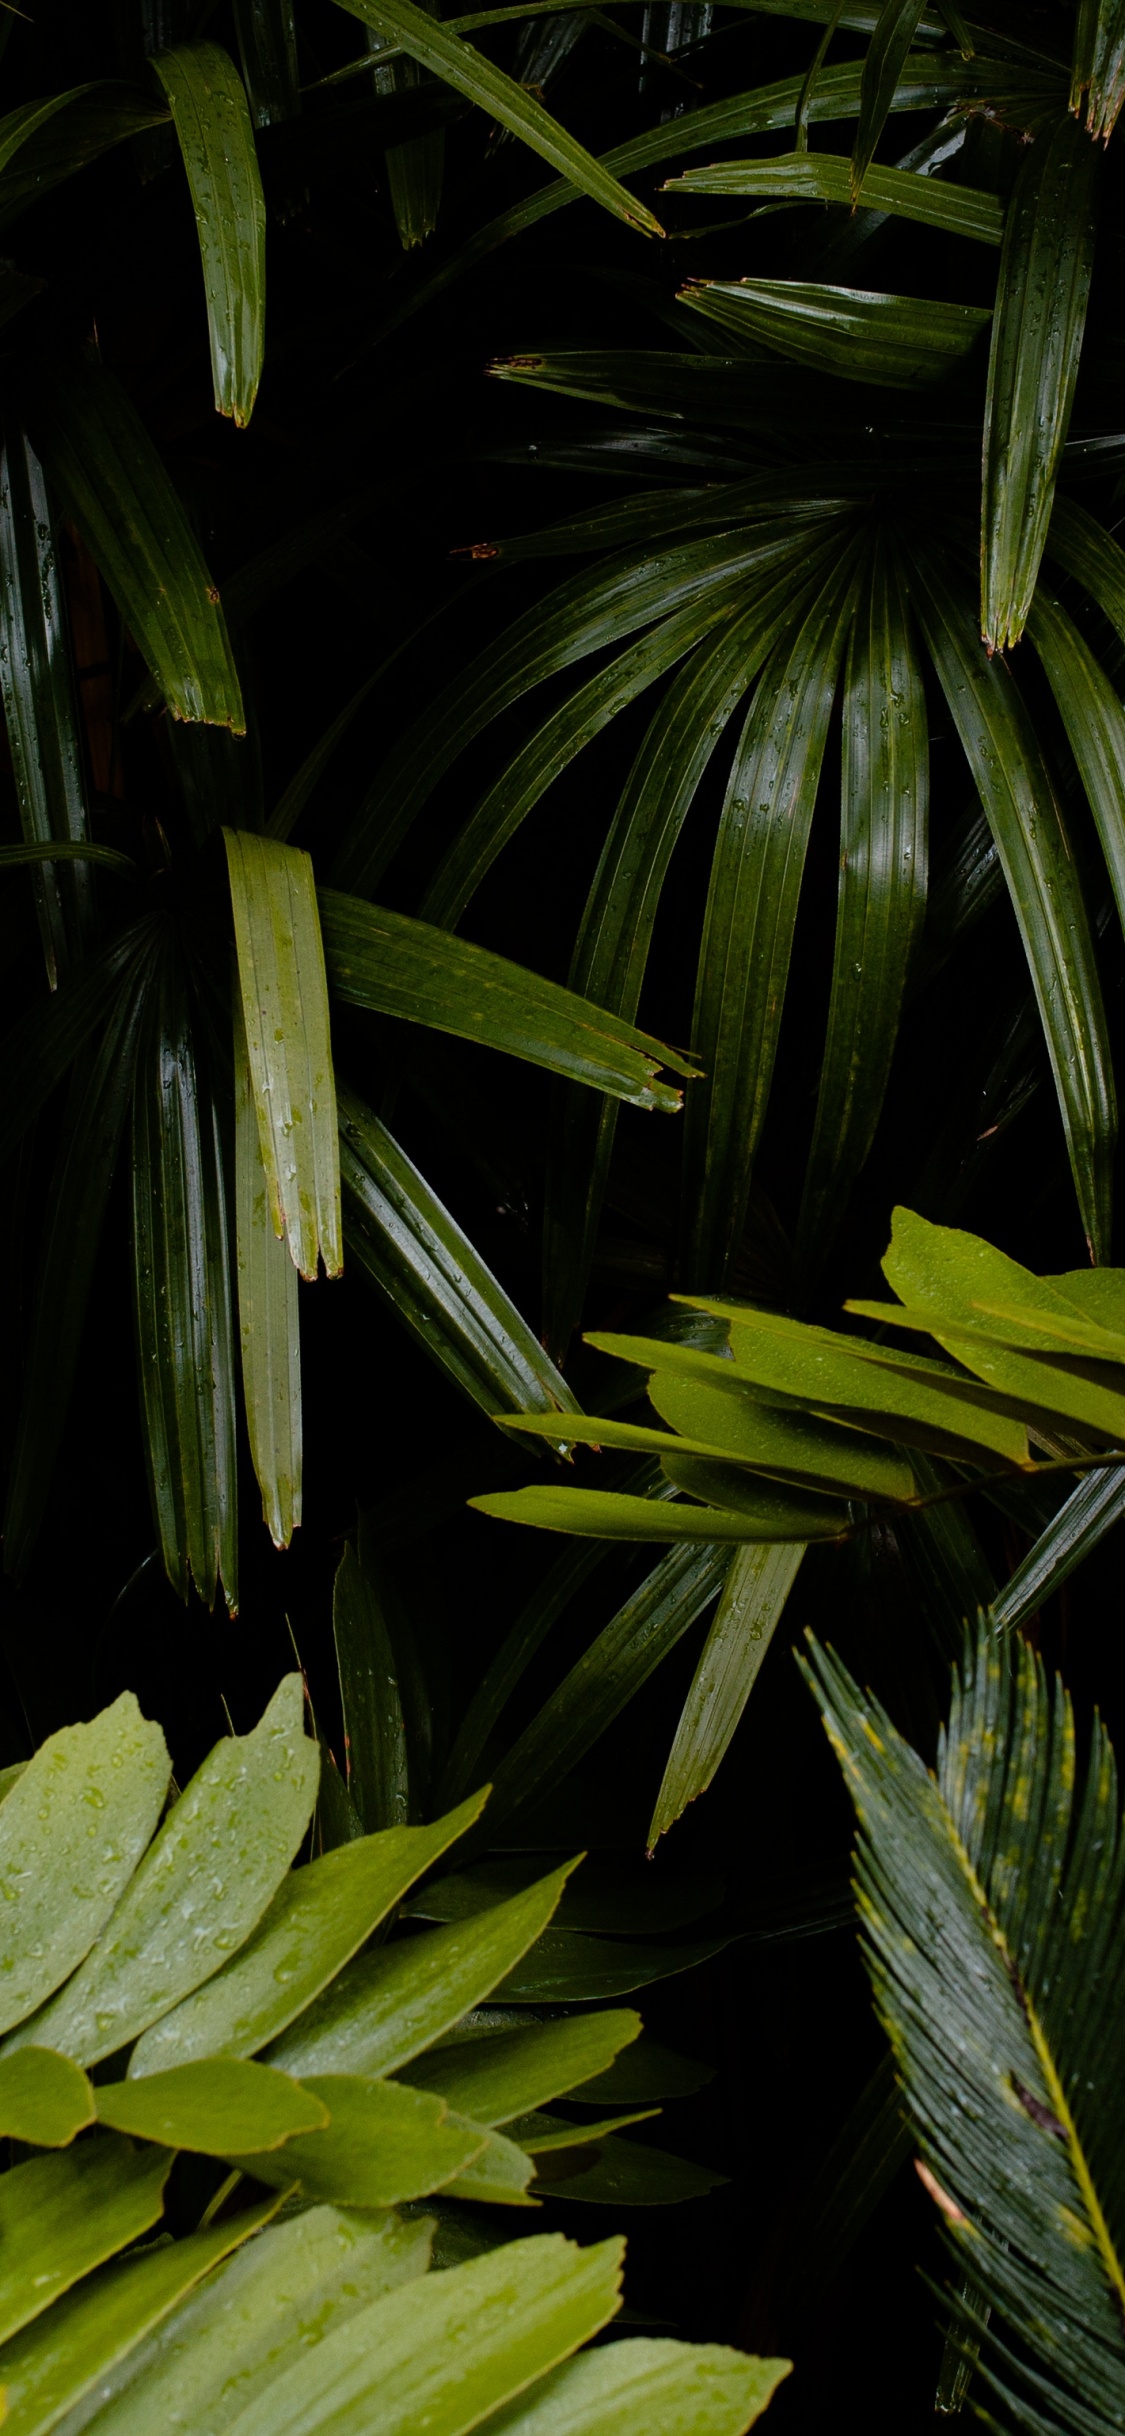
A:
[[151, 41, 265, 429]]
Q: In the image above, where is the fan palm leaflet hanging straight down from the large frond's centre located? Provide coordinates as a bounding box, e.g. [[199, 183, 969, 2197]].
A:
[[796, 536, 930, 1279]]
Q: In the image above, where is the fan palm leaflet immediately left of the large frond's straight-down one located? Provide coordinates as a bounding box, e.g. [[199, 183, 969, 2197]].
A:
[[684, 546, 857, 1284]]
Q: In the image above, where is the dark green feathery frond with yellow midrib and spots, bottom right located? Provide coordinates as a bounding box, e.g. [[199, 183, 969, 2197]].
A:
[[806, 1625, 1125, 2436]]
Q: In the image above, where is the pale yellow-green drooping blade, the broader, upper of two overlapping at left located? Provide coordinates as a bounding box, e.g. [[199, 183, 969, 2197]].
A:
[[222, 828, 343, 1276]]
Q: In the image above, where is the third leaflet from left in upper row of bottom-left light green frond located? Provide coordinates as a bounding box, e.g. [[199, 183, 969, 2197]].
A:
[[129, 1793, 485, 2080]]
